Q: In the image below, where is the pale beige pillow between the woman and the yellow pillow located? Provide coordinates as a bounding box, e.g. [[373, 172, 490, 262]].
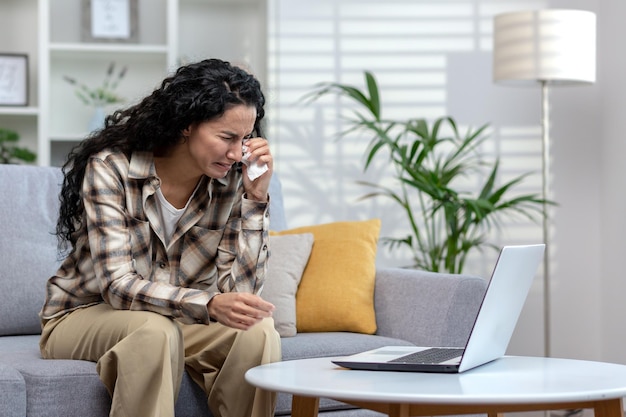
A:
[[261, 233, 313, 337]]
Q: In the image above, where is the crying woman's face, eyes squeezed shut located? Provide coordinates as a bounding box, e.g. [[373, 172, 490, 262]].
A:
[[184, 104, 256, 178]]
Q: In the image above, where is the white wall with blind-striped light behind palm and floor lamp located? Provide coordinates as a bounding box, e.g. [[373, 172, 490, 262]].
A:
[[269, 0, 626, 363]]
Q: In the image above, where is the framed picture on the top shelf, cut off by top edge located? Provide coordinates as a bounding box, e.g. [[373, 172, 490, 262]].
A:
[[81, 0, 138, 43]]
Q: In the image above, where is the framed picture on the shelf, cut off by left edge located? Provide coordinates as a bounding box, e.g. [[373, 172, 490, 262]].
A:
[[0, 53, 28, 106]]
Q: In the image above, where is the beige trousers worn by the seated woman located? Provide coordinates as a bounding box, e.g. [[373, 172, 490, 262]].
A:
[[40, 304, 281, 417]]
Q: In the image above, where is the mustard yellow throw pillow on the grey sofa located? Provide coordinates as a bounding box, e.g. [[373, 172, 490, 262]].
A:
[[271, 219, 380, 334]]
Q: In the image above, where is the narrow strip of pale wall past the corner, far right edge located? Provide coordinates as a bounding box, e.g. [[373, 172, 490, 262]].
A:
[[594, 0, 626, 363]]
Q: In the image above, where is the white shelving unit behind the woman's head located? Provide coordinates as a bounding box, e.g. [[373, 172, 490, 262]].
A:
[[0, 0, 267, 166]]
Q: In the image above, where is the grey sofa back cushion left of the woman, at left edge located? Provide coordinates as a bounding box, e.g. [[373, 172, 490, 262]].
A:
[[0, 165, 62, 335]]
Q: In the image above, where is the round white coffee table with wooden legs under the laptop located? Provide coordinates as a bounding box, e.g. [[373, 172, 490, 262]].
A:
[[246, 356, 626, 417]]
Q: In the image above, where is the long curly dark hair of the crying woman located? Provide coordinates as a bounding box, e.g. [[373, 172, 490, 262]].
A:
[[56, 59, 265, 251]]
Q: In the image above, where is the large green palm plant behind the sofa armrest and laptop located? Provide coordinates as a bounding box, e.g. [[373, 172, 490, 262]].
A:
[[304, 71, 552, 273]]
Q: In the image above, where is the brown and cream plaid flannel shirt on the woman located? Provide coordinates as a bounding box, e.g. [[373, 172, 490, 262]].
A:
[[40, 151, 269, 324]]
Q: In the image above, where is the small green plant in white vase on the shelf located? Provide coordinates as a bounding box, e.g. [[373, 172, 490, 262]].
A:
[[63, 62, 127, 131]]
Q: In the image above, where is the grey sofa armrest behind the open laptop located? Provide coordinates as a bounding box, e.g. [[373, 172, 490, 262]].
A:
[[374, 268, 487, 347]]
